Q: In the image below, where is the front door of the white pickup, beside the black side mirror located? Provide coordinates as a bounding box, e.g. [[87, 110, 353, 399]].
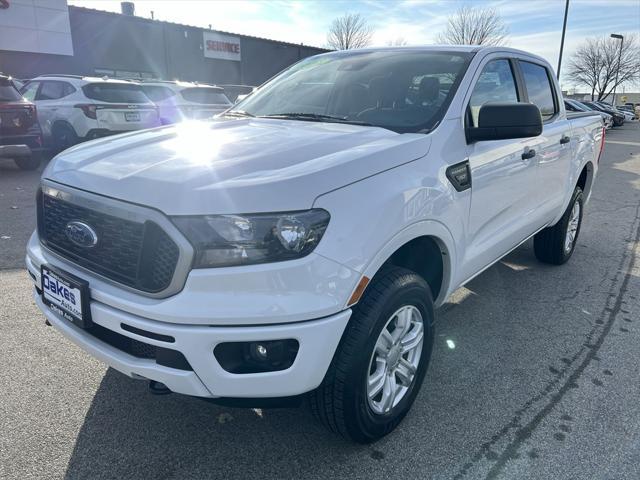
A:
[[462, 54, 539, 279]]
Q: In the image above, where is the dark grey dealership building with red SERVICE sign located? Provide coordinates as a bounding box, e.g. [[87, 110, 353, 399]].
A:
[[0, 0, 327, 85]]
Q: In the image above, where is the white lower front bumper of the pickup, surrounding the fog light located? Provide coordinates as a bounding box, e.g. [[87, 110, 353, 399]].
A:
[[34, 289, 351, 398]]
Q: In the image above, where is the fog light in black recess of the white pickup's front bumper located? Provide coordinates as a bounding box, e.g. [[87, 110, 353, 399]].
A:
[[213, 338, 300, 373]]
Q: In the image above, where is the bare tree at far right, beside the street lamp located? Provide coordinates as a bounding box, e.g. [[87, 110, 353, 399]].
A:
[[566, 35, 640, 100]]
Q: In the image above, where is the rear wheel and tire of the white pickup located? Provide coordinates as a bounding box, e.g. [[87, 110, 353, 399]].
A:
[[533, 187, 584, 265]]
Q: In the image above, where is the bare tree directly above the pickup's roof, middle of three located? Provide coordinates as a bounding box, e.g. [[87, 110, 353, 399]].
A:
[[436, 6, 509, 45]]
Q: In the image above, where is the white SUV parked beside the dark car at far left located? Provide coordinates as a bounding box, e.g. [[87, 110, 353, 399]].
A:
[[21, 75, 160, 150]]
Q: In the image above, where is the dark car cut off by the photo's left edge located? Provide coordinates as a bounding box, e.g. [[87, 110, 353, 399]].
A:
[[0, 74, 42, 170]]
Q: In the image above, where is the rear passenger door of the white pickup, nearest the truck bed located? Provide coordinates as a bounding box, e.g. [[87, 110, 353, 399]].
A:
[[517, 59, 578, 222]]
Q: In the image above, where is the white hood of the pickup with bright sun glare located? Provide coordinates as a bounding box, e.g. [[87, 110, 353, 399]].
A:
[[43, 119, 430, 215]]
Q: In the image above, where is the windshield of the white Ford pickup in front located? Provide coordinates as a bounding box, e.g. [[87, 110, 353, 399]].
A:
[[230, 50, 471, 133]]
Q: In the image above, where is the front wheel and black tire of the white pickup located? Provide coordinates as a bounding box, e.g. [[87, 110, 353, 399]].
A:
[[309, 267, 434, 443]]
